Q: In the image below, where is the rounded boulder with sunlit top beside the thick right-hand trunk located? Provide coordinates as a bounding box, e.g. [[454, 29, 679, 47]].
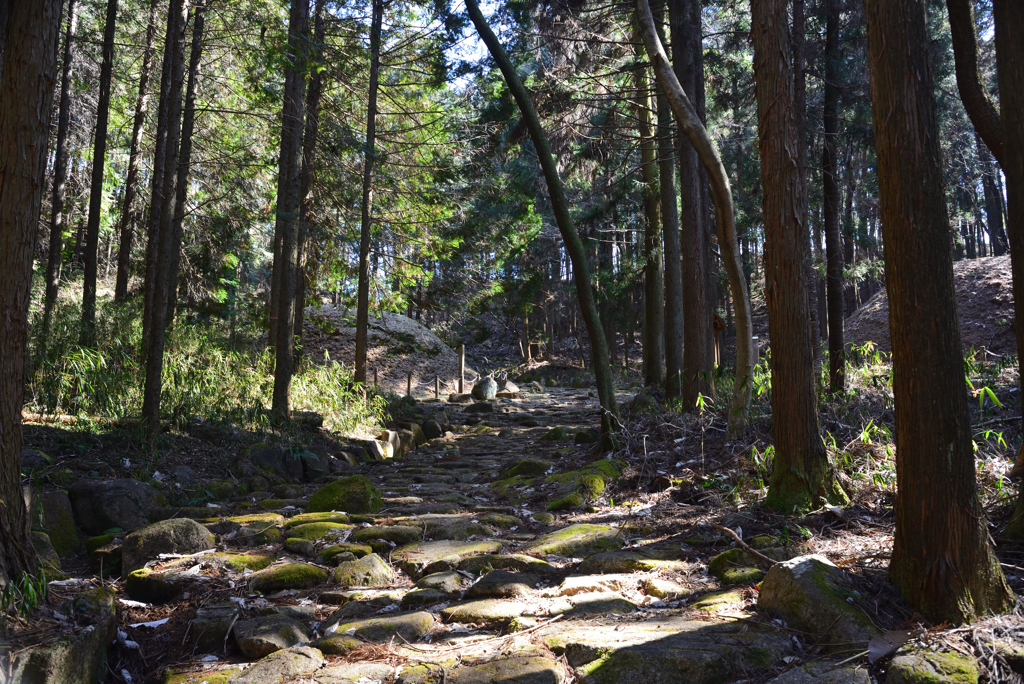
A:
[[758, 554, 880, 649]]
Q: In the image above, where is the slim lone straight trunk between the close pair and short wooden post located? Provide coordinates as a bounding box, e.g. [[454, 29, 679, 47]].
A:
[[355, 0, 384, 384]]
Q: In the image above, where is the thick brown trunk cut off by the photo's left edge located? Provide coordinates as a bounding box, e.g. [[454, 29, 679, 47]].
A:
[[0, 0, 62, 581]]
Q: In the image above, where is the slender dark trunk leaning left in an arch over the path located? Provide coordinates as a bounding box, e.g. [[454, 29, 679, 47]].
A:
[[466, 0, 618, 435]]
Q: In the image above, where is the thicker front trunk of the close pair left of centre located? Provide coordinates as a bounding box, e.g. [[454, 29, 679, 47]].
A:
[[273, 0, 309, 420]]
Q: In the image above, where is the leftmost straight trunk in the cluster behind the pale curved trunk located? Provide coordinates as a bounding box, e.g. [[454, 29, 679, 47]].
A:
[[633, 24, 665, 387]]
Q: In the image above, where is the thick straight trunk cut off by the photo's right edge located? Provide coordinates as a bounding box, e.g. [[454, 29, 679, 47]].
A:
[[992, 0, 1024, 539]]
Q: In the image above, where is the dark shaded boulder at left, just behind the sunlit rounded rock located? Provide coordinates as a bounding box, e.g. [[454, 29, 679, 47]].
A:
[[68, 478, 164, 535]]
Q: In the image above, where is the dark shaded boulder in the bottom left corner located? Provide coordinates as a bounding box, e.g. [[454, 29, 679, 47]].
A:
[[3, 587, 117, 684]]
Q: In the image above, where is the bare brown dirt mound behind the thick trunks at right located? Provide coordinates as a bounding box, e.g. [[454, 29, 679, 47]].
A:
[[845, 256, 1017, 354]]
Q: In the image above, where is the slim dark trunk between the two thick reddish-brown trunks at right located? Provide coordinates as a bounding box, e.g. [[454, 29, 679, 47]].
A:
[[821, 0, 846, 393]]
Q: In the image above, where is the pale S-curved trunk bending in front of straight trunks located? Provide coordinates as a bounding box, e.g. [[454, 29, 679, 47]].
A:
[[636, 0, 755, 437]]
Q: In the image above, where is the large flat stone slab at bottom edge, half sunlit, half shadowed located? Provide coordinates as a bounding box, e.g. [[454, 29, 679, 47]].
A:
[[540, 616, 790, 684]]
